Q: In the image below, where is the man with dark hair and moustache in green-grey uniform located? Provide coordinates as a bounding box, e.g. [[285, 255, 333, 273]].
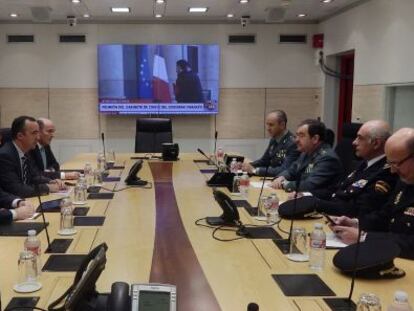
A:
[[271, 119, 342, 199]]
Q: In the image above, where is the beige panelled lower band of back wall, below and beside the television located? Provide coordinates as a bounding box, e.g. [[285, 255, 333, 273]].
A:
[[0, 88, 321, 139]]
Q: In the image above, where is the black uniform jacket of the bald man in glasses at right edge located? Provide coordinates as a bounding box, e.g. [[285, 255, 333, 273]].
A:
[[360, 181, 414, 259]]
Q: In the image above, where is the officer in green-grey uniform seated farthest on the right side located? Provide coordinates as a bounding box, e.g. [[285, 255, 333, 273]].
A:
[[243, 110, 300, 176]]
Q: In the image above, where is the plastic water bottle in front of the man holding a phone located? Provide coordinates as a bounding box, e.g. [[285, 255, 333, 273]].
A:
[[309, 223, 326, 270]]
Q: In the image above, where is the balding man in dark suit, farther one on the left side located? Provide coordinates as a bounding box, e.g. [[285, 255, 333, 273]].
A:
[[29, 118, 79, 179]]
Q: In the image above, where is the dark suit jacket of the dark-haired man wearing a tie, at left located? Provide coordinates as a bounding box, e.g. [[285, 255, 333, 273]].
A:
[[0, 142, 50, 198]]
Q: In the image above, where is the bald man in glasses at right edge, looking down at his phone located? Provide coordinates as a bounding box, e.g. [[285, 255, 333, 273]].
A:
[[332, 128, 414, 259]]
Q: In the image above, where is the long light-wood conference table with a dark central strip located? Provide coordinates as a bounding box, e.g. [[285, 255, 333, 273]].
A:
[[0, 154, 414, 311]]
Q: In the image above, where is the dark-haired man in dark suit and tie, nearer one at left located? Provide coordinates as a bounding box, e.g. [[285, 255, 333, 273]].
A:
[[0, 116, 66, 198]]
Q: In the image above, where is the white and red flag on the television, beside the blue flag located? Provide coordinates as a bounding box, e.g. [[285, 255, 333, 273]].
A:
[[152, 55, 171, 103]]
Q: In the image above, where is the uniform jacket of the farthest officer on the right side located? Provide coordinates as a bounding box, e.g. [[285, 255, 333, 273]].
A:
[[251, 131, 300, 176]]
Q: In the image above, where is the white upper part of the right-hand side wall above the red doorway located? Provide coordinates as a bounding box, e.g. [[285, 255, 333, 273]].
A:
[[319, 0, 414, 85]]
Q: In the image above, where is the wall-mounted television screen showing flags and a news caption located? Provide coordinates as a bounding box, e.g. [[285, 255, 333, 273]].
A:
[[98, 44, 220, 114]]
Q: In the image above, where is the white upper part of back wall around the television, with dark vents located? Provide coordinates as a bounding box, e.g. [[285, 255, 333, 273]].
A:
[[0, 24, 320, 88]]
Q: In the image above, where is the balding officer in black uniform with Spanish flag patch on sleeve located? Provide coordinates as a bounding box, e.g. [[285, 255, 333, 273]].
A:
[[314, 120, 398, 217]]
